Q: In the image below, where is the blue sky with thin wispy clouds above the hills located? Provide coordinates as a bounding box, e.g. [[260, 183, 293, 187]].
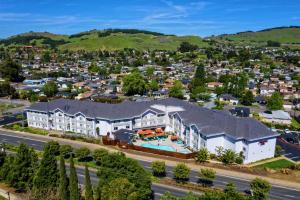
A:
[[0, 0, 300, 38]]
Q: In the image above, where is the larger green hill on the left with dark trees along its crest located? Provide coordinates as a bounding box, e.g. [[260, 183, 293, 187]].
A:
[[0, 29, 207, 50]]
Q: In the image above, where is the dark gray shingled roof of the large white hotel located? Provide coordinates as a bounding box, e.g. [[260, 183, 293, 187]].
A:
[[27, 98, 277, 140]]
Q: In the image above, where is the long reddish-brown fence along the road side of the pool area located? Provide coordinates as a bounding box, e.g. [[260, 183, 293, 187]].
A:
[[102, 137, 196, 159]]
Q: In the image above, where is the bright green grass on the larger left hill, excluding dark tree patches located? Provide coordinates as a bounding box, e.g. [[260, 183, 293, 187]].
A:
[[1, 31, 208, 51]]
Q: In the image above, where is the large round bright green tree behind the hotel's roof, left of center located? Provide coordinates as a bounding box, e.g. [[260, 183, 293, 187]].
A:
[[123, 71, 146, 96]]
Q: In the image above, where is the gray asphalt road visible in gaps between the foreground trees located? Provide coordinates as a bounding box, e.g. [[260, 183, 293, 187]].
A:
[[0, 131, 300, 200]]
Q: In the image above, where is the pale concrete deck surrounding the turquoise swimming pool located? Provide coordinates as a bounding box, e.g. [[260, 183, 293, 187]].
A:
[[133, 136, 191, 153]]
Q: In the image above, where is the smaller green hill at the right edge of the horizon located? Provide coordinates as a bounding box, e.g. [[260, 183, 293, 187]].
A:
[[216, 26, 300, 44]]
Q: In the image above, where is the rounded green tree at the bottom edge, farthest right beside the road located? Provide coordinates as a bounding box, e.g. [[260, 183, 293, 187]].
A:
[[250, 178, 271, 199]]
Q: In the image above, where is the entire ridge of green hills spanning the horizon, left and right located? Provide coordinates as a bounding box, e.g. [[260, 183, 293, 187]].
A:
[[0, 26, 300, 51]]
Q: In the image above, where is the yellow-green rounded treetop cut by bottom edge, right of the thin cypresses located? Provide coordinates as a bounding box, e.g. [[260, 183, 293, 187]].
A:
[[101, 178, 139, 200]]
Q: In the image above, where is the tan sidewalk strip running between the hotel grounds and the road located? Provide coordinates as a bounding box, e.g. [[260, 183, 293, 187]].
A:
[[0, 128, 300, 190]]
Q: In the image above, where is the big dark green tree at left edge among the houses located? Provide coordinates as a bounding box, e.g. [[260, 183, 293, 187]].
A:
[[0, 59, 24, 82]]
